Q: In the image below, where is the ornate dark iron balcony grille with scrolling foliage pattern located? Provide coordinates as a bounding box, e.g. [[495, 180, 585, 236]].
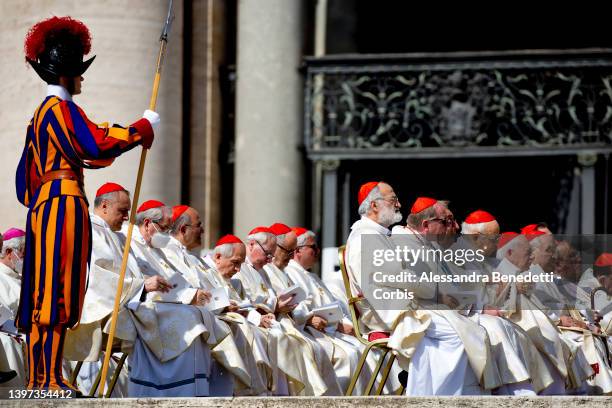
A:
[[305, 50, 612, 159]]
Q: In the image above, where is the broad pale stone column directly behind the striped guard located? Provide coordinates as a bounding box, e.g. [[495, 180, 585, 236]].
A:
[[0, 0, 183, 230]]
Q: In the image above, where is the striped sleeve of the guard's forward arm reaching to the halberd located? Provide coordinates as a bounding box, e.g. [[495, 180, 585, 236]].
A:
[[45, 101, 153, 165]]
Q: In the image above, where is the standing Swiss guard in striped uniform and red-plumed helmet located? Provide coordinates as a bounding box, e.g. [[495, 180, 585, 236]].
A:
[[16, 17, 159, 390]]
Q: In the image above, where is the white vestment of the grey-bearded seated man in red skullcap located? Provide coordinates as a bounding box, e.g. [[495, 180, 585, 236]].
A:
[[346, 217, 500, 395]]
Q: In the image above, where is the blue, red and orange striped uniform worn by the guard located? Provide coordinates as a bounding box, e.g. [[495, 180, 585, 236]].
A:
[[16, 95, 153, 389]]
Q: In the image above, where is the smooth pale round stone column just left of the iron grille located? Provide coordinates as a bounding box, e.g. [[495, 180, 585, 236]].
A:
[[234, 0, 304, 237]]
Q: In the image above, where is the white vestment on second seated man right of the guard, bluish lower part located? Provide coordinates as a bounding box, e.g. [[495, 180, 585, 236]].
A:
[[118, 229, 251, 397]]
